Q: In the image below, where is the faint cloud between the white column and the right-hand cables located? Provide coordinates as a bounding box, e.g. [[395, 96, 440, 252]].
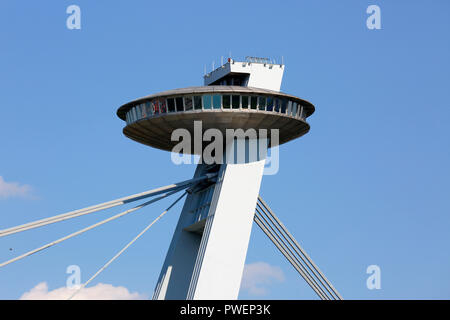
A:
[[241, 262, 284, 295]]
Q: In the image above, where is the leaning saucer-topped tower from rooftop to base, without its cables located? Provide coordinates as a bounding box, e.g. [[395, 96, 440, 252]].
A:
[[117, 57, 342, 300]]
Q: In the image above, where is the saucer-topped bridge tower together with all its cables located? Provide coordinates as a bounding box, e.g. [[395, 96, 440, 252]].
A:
[[0, 57, 342, 300]]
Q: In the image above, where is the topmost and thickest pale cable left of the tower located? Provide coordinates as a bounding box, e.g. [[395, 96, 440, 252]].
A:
[[0, 173, 217, 237]]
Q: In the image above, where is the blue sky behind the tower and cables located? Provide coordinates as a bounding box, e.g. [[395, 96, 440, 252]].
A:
[[0, 0, 450, 299]]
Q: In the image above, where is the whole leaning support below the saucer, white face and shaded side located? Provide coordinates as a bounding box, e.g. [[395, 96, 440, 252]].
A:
[[153, 140, 265, 300]]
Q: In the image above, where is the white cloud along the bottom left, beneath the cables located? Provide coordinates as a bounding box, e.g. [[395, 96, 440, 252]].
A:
[[20, 282, 147, 300]]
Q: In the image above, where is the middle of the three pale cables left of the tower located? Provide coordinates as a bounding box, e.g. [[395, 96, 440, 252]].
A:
[[0, 190, 186, 268]]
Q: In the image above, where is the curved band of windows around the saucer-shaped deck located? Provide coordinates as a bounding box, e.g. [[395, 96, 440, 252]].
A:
[[126, 94, 305, 124]]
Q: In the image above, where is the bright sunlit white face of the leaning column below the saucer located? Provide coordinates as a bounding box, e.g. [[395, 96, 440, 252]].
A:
[[188, 160, 265, 300]]
